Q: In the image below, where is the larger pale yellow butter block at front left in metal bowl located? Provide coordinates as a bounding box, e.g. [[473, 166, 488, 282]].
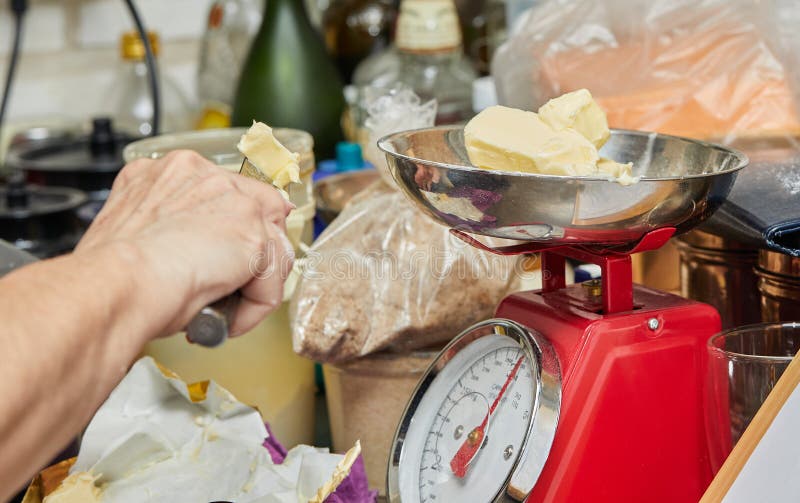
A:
[[464, 106, 599, 176]]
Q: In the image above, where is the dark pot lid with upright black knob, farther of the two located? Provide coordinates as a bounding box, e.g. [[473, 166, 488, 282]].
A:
[[7, 118, 136, 173]]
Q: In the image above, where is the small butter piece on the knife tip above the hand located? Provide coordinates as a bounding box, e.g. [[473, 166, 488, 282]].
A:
[[236, 121, 300, 189]]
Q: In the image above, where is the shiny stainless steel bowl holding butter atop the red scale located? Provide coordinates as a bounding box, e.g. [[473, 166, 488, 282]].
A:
[[378, 126, 747, 246]]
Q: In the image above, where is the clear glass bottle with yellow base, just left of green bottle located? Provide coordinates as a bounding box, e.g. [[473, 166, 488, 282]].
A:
[[197, 0, 263, 129]]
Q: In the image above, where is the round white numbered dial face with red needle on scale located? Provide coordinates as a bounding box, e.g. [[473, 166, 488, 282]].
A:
[[399, 335, 536, 503]]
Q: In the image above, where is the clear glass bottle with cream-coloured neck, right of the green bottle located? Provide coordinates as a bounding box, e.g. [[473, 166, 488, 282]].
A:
[[354, 0, 477, 124]]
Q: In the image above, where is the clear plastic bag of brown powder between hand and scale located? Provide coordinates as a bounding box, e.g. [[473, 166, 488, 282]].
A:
[[290, 184, 517, 362]]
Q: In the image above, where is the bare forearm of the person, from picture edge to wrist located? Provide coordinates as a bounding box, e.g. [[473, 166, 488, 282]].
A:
[[0, 247, 159, 500]]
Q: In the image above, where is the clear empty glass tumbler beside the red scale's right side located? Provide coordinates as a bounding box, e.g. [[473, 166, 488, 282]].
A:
[[705, 322, 800, 473]]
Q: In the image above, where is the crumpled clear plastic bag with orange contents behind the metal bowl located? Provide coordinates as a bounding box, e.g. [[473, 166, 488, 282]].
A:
[[492, 0, 800, 142]]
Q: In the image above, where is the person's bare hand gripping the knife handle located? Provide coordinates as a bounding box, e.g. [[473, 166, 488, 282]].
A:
[[75, 151, 294, 335]]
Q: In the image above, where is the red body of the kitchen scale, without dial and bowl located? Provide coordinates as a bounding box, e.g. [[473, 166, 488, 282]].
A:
[[497, 285, 720, 503]]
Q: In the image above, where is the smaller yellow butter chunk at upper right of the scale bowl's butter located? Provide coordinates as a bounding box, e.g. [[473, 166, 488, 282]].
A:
[[539, 89, 611, 148]]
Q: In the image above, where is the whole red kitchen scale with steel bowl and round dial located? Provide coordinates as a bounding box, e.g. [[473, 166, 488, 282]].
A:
[[379, 127, 747, 503]]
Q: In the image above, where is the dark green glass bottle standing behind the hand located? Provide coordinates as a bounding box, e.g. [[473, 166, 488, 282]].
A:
[[231, 0, 344, 159]]
